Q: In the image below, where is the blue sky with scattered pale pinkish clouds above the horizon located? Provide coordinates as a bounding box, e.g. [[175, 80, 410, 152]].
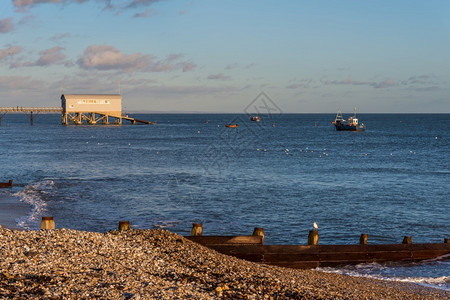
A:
[[0, 0, 450, 113]]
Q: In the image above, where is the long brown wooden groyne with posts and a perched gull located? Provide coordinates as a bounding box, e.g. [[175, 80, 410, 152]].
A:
[[186, 224, 450, 269]]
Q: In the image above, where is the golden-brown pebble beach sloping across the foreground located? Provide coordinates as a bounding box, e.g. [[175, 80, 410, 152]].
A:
[[0, 228, 450, 299]]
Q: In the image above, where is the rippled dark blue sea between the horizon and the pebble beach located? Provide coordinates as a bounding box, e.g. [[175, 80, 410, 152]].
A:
[[0, 111, 450, 291]]
